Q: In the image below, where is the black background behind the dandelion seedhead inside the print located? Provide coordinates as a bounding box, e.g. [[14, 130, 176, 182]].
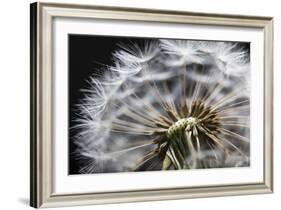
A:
[[68, 34, 250, 174]]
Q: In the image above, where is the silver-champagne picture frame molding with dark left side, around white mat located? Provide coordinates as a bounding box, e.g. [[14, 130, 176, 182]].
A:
[[30, 2, 273, 208]]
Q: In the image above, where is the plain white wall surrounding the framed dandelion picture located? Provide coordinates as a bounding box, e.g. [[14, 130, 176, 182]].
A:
[[0, 0, 281, 210]]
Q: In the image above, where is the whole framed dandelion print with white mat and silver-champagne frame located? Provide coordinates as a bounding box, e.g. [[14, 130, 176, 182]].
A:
[[30, 3, 273, 208]]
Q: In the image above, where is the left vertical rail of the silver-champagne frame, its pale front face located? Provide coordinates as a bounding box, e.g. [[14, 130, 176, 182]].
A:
[[42, 0, 55, 207]]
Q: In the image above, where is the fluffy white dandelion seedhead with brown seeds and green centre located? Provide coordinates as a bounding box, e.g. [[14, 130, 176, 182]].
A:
[[72, 39, 250, 173]]
